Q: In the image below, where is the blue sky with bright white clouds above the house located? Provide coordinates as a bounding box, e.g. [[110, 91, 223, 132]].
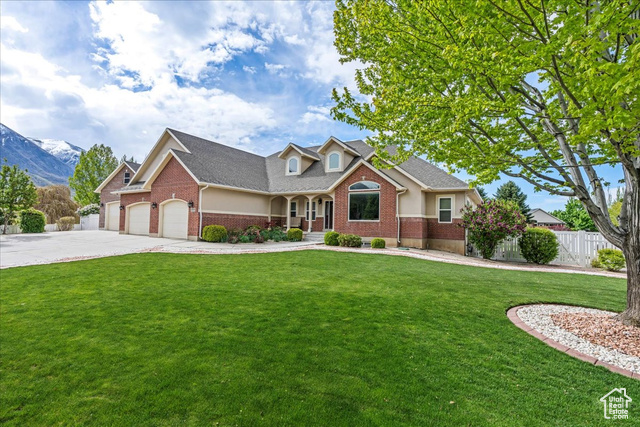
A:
[[0, 1, 622, 210]]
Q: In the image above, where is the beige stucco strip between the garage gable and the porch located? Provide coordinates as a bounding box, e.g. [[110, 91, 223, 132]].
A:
[[202, 187, 271, 215]]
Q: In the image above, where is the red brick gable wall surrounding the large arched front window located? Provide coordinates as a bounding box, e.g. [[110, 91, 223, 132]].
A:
[[333, 165, 398, 237]]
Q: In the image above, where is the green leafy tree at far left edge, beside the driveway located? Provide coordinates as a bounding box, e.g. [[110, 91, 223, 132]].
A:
[[0, 163, 38, 234]]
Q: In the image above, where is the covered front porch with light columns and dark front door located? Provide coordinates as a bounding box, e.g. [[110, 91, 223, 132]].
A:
[[269, 193, 335, 233]]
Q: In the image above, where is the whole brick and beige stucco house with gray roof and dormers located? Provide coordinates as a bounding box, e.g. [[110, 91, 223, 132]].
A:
[[95, 129, 481, 253]]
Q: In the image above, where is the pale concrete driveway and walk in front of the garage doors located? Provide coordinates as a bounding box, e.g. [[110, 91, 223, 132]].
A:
[[0, 231, 318, 268]]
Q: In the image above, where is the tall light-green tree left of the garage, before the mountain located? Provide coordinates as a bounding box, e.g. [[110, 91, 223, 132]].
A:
[[69, 144, 118, 206]]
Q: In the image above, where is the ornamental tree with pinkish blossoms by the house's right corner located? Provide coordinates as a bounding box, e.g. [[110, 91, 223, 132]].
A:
[[461, 200, 527, 259]]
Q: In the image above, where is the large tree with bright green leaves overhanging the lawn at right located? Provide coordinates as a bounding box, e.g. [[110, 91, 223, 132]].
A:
[[332, 0, 640, 325]]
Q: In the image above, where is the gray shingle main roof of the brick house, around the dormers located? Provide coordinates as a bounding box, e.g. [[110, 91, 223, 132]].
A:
[[154, 129, 469, 193]]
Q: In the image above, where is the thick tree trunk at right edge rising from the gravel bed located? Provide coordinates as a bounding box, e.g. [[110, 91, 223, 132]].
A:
[[618, 187, 640, 326]]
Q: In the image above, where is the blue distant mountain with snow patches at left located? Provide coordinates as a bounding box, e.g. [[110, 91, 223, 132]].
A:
[[0, 123, 84, 186]]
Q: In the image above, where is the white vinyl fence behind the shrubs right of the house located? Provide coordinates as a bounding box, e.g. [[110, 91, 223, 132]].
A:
[[471, 231, 618, 267]]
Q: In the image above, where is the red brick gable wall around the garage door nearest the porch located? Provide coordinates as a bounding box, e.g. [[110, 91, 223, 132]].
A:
[[148, 158, 200, 236]]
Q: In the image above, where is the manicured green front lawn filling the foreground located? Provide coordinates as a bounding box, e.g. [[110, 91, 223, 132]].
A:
[[0, 251, 640, 426]]
